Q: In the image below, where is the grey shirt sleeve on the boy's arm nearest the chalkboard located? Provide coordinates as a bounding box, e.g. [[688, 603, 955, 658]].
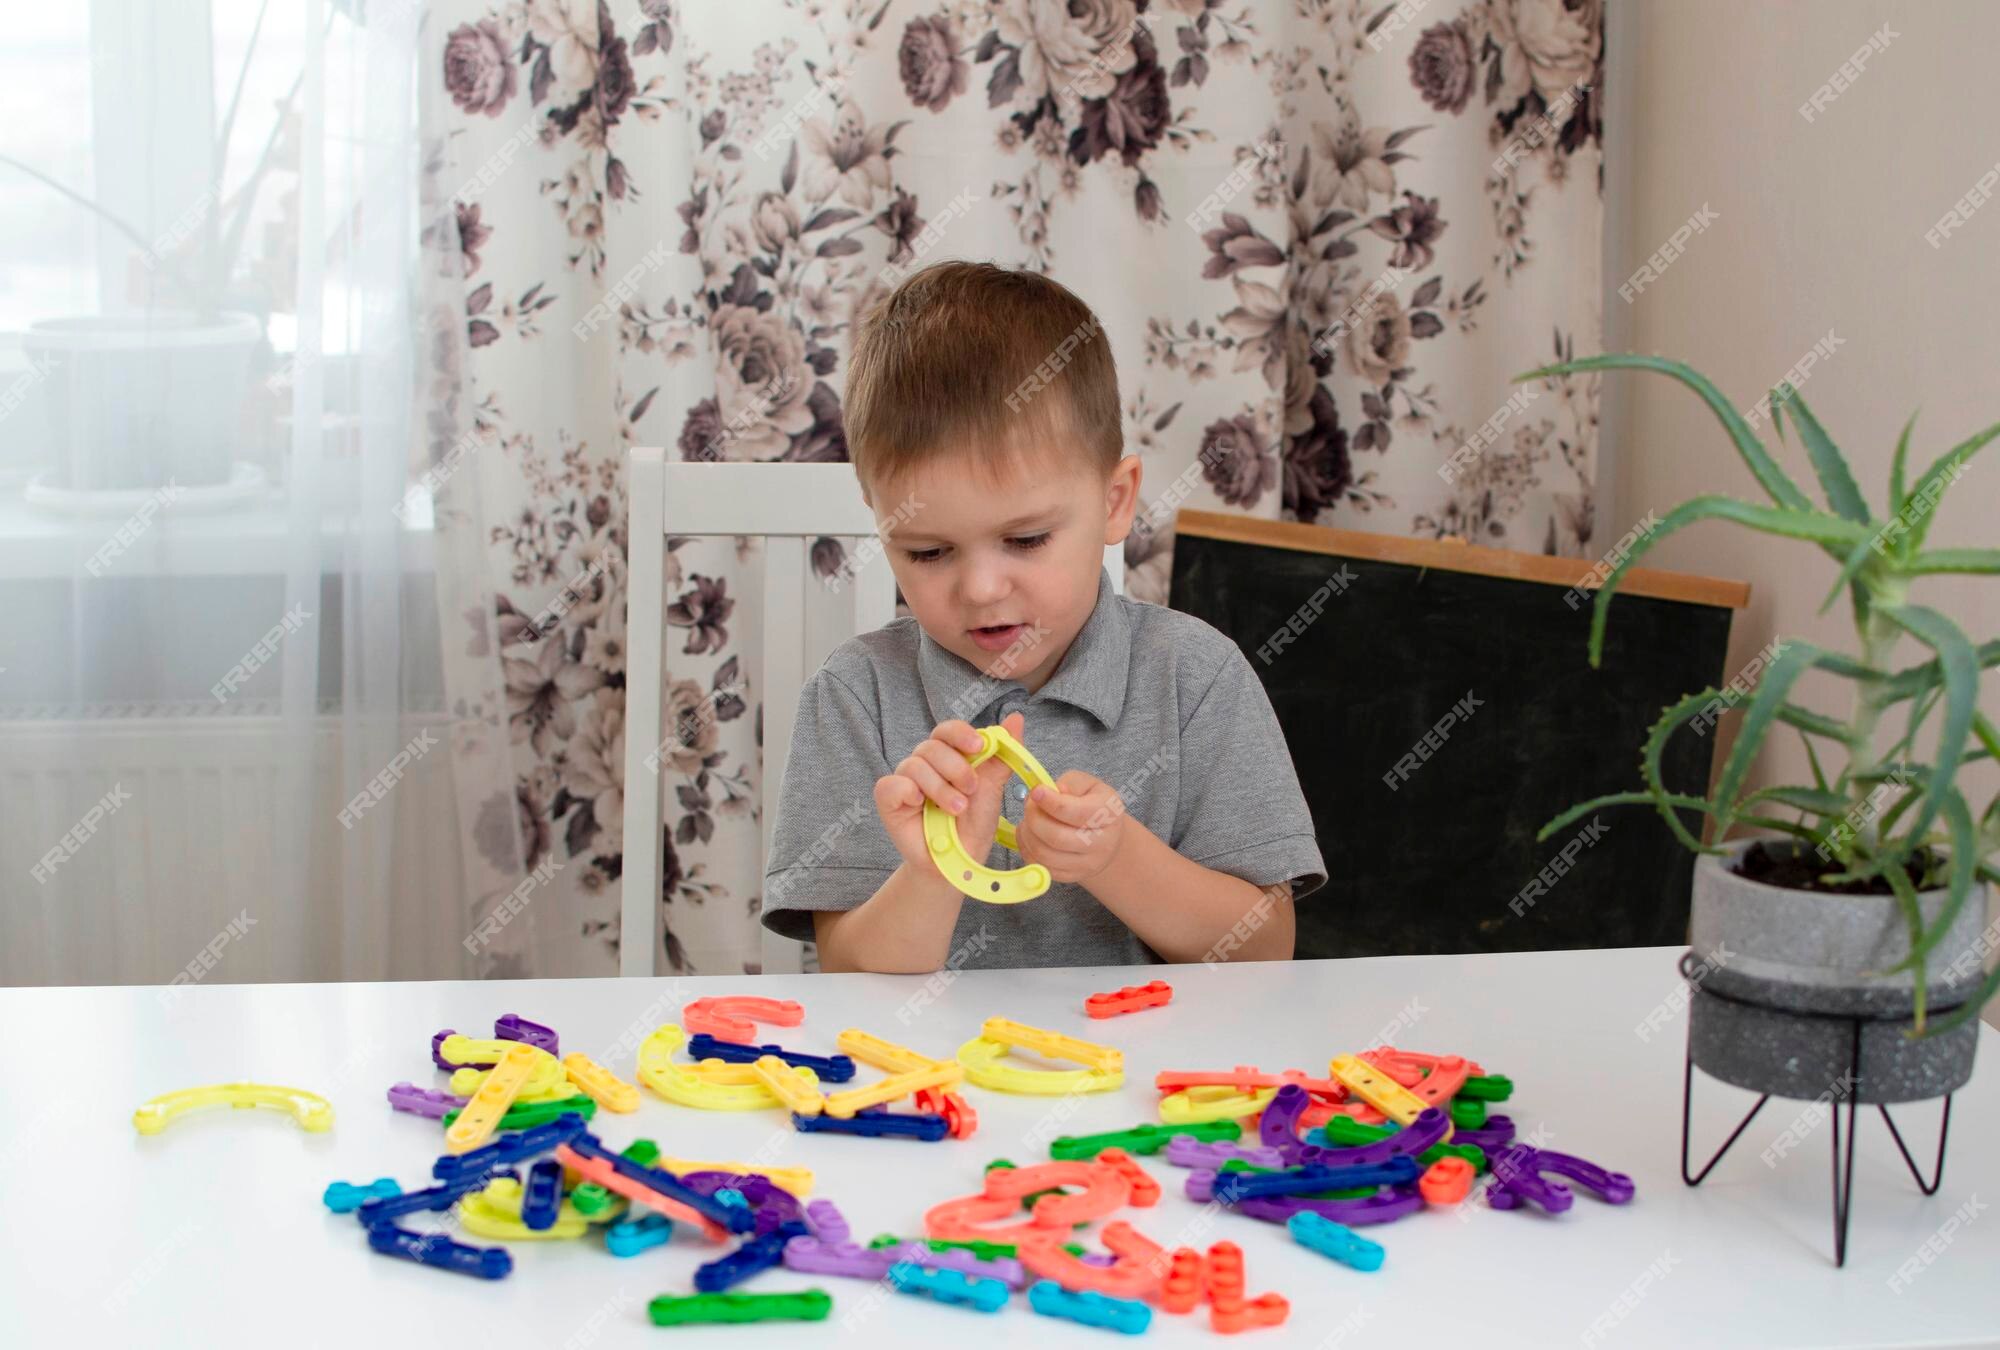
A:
[[1172, 644, 1326, 900]]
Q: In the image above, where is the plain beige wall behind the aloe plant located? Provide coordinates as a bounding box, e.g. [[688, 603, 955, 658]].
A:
[[1598, 0, 2000, 1020]]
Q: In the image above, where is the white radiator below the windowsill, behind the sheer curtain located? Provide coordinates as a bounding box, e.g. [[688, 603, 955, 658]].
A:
[[0, 706, 470, 984]]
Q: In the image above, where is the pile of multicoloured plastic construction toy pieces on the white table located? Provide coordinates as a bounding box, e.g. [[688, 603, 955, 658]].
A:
[[304, 982, 1632, 1332]]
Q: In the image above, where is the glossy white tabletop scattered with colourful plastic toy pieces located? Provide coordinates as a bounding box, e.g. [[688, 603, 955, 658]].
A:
[[0, 948, 2000, 1350]]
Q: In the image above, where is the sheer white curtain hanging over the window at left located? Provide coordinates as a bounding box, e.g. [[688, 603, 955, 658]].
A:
[[0, 0, 534, 984]]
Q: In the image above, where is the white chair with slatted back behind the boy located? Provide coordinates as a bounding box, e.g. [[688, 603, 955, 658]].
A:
[[618, 446, 1124, 976]]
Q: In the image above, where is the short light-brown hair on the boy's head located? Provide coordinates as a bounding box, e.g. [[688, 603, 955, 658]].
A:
[[842, 262, 1124, 496]]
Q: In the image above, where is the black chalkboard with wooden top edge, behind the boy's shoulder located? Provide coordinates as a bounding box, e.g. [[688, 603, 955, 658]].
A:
[[1168, 512, 1748, 956]]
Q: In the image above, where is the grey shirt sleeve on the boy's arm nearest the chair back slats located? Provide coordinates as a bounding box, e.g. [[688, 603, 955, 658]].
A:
[[764, 666, 902, 942]]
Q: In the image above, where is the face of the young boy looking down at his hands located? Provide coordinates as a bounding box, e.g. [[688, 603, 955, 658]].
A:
[[864, 454, 1140, 694]]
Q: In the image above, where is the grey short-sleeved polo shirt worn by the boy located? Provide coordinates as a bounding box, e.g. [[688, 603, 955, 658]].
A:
[[764, 572, 1326, 968]]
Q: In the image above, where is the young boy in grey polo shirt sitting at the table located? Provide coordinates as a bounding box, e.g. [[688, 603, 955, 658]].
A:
[[764, 262, 1326, 972]]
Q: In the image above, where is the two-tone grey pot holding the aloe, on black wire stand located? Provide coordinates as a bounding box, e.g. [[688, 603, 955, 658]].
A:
[[1688, 840, 1986, 1104]]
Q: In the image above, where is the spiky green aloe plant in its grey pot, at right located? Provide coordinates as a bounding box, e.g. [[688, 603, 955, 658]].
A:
[[1518, 356, 2000, 1102]]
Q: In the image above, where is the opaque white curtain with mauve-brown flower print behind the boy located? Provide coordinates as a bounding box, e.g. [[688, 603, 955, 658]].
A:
[[424, 0, 1604, 974]]
